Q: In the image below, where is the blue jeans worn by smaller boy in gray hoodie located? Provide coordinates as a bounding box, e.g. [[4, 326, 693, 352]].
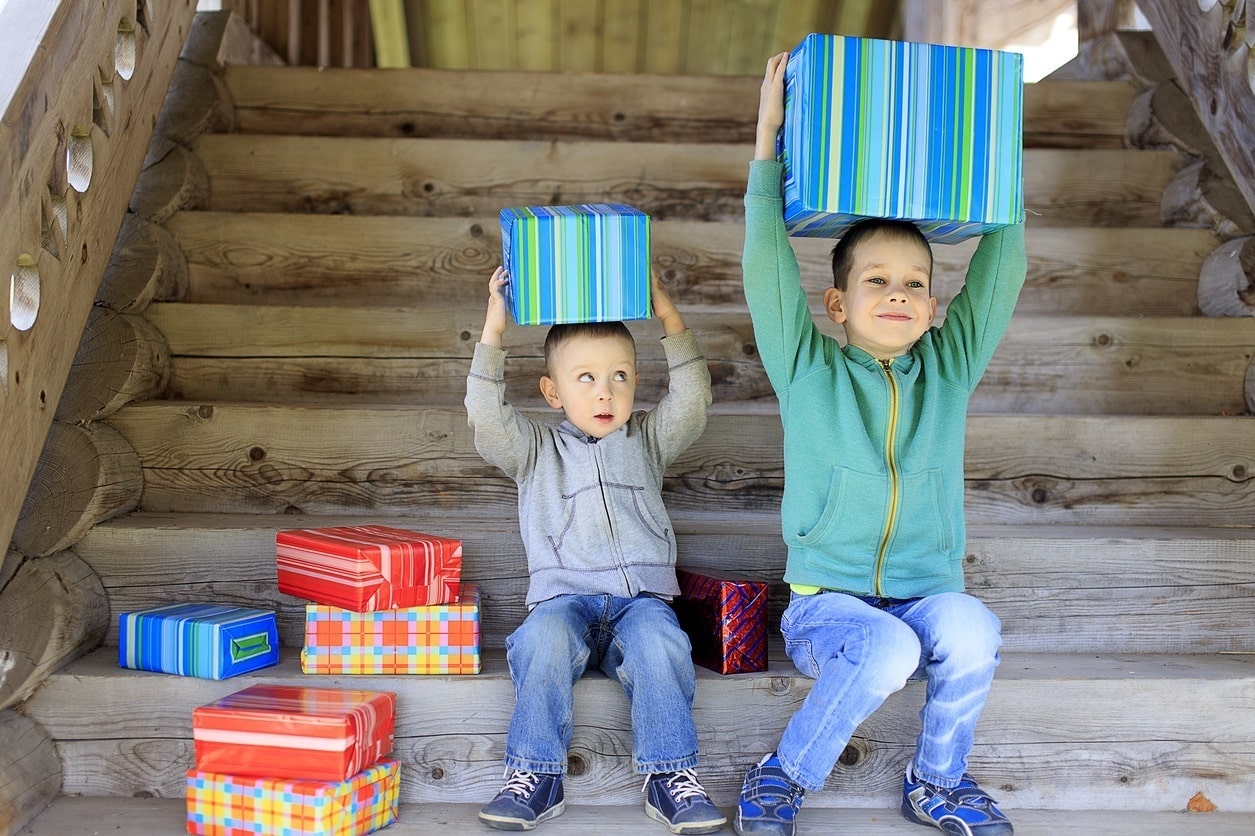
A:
[[506, 595, 698, 773]]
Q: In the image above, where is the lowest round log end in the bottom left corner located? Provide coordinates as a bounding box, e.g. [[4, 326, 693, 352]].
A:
[[0, 712, 61, 833]]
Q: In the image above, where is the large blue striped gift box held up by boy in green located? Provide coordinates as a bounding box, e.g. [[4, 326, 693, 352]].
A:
[[781, 35, 1024, 244]]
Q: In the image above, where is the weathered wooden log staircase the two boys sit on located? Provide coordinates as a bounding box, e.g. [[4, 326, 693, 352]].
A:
[[9, 6, 1255, 836]]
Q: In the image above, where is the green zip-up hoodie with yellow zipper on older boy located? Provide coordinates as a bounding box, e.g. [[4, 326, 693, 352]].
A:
[[742, 161, 1027, 599]]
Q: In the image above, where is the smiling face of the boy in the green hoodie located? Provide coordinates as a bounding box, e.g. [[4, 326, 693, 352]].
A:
[[823, 232, 937, 360]]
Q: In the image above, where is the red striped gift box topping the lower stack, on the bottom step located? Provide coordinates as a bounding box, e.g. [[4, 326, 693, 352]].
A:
[[192, 684, 397, 781]]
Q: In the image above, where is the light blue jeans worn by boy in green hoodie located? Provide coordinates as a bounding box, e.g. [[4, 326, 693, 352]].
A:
[[777, 584, 1001, 790]]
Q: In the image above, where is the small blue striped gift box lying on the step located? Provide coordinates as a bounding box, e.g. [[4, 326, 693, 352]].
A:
[[118, 604, 279, 679]]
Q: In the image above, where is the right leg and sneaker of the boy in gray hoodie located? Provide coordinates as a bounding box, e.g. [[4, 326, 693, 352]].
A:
[[601, 595, 728, 833]]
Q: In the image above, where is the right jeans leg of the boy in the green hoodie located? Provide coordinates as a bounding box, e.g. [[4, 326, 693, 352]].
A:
[[895, 592, 1003, 787]]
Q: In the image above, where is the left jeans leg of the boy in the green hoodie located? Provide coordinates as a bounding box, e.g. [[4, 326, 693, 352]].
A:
[[777, 592, 920, 790]]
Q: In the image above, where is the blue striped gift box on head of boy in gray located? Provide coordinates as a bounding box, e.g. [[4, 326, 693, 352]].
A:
[[501, 203, 653, 325]]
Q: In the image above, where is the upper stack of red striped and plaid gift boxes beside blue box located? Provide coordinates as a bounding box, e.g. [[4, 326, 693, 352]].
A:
[[275, 526, 479, 674]]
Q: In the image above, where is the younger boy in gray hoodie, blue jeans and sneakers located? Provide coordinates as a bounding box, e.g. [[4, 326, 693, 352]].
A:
[[466, 267, 727, 833]]
